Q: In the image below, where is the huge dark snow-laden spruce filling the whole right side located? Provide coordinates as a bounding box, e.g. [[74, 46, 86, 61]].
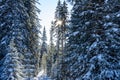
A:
[[63, 0, 120, 80]]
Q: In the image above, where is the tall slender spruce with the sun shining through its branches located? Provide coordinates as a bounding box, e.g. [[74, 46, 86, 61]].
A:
[[52, 0, 68, 79]]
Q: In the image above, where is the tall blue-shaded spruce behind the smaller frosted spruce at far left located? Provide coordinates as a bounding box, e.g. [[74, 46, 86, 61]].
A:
[[0, 0, 39, 77]]
